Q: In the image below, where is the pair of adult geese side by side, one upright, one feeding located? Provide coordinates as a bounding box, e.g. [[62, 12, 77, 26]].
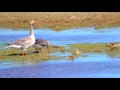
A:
[[6, 20, 50, 56]]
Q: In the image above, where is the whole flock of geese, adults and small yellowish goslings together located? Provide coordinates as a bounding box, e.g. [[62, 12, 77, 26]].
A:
[[6, 20, 120, 60]]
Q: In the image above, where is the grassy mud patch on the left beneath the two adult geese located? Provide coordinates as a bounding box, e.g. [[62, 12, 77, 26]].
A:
[[0, 46, 64, 61]]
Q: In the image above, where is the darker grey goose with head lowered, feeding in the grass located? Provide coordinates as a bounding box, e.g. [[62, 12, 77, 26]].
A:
[[33, 38, 50, 53]]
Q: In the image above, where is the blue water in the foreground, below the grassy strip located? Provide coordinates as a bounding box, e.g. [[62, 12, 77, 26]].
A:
[[0, 54, 120, 78]]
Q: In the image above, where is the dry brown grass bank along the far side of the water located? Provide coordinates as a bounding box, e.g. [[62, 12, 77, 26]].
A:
[[0, 12, 120, 30]]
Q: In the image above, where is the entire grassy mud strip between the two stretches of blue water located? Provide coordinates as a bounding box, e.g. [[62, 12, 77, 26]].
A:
[[0, 43, 120, 63]]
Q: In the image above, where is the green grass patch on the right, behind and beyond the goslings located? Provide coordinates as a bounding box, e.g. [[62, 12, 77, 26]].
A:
[[69, 43, 120, 57]]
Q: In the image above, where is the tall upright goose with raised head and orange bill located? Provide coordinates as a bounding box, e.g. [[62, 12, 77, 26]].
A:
[[6, 20, 37, 56]]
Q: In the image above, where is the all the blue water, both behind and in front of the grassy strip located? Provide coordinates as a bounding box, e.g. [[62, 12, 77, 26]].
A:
[[0, 27, 120, 78]]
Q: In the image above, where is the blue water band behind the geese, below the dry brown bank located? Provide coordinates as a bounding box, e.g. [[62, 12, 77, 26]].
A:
[[0, 27, 120, 46]]
